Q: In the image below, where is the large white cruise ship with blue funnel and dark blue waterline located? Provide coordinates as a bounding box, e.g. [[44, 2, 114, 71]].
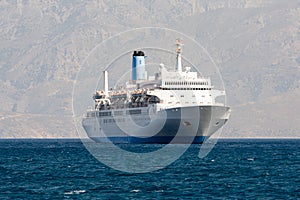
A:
[[82, 39, 230, 144]]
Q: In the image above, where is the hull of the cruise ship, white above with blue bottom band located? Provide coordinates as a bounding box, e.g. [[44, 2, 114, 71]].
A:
[[82, 105, 230, 144]]
